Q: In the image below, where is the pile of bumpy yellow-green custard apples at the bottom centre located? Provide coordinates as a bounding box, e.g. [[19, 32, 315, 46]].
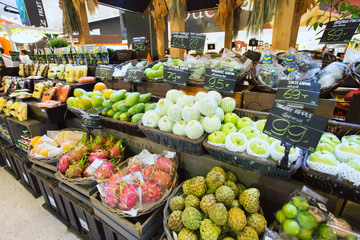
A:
[[167, 167, 267, 240]]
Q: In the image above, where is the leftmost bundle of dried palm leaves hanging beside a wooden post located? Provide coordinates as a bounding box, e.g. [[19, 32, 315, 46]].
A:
[[62, 0, 82, 36]]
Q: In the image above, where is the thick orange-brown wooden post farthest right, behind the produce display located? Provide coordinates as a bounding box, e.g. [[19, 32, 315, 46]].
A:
[[272, 0, 301, 50]]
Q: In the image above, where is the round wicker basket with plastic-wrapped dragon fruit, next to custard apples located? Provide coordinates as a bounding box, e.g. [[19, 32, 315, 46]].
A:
[[98, 150, 178, 217]]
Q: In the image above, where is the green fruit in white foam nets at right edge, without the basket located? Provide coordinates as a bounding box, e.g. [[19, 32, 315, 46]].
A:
[[307, 133, 360, 186]]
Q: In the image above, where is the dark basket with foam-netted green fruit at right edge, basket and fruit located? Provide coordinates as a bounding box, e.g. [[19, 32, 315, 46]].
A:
[[301, 121, 360, 202]]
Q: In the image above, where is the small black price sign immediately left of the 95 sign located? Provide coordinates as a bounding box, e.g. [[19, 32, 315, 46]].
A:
[[164, 64, 189, 87]]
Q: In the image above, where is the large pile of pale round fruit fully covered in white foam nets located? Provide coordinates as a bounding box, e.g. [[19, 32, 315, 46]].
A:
[[142, 89, 236, 139]]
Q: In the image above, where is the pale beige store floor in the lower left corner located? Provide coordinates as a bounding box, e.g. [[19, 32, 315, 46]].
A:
[[0, 168, 78, 240]]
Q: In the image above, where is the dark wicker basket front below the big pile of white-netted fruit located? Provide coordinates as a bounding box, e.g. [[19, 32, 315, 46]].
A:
[[138, 121, 207, 156]]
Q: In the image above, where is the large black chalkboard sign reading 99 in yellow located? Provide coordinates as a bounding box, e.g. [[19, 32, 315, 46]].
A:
[[263, 102, 328, 152]]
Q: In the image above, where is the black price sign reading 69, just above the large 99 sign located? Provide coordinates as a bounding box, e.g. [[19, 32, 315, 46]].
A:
[[275, 80, 320, 109]]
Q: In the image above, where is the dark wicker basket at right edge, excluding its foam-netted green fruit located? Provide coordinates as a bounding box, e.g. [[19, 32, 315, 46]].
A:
[[301, 121, 360, 203]]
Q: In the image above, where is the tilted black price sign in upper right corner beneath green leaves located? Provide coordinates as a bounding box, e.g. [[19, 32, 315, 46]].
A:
[[320, 18, 360, 43]]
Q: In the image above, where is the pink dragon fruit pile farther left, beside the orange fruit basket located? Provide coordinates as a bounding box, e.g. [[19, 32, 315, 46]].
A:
[[58, 136, 125, 181]]
